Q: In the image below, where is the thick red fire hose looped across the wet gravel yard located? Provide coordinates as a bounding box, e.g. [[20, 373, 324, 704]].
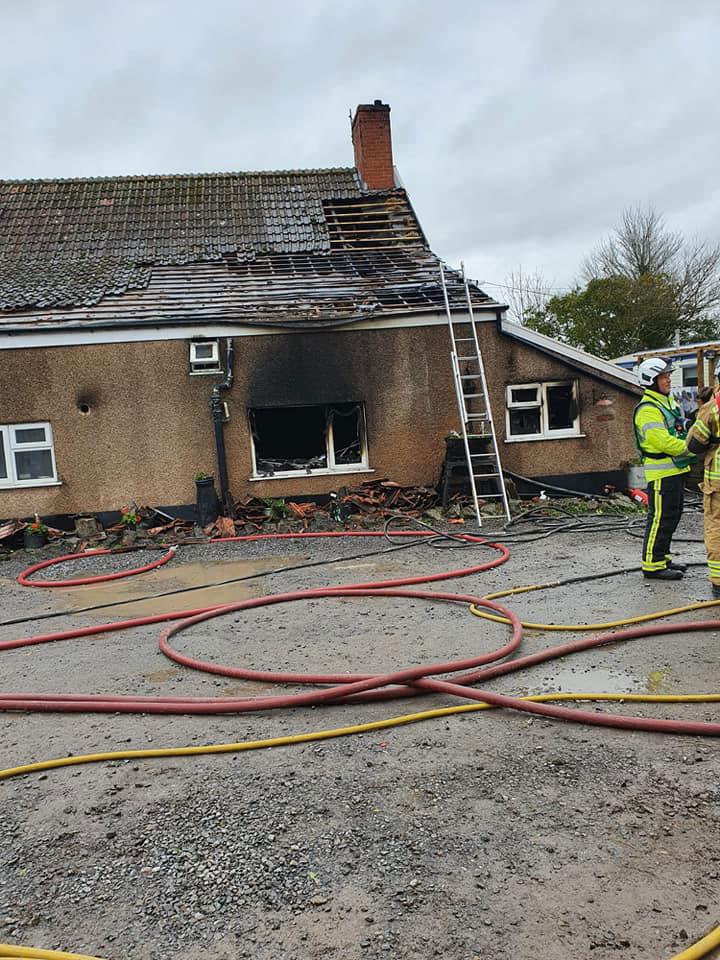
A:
[[0, 531, 720, 736]]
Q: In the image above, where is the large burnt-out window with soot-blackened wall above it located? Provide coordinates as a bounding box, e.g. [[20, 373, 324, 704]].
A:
[[249, 403, 368, 479]]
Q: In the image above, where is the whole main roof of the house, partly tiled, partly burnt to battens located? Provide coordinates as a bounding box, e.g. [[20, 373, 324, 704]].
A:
[[0, 167, 494, 325]]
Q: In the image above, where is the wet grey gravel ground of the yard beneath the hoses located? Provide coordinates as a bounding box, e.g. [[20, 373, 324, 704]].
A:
[[0, 515, 720, 960]]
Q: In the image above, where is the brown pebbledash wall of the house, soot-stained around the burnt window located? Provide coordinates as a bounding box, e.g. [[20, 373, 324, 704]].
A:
[[0, 322, 637, 518]]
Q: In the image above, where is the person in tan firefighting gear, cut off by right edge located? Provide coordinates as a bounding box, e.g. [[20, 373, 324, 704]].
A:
[[688, 360, 720, 599]]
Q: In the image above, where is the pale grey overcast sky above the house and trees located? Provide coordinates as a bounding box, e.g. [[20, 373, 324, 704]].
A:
[[0, 0, 720, 299]]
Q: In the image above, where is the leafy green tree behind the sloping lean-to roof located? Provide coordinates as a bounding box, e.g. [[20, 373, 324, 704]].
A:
[[526, 273, 677, 359]]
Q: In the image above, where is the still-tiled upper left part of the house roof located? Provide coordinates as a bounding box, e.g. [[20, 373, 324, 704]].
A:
[[0, 168, 362, 310]]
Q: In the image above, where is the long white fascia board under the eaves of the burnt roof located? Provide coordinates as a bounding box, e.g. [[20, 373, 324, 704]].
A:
[[0, 304, 504, 350]]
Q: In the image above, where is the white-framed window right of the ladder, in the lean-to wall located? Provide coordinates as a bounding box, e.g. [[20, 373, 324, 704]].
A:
[[506, 381, 580, 441]]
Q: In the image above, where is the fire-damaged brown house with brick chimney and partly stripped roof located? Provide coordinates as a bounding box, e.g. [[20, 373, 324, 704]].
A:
[[0, 101, 638, 517]]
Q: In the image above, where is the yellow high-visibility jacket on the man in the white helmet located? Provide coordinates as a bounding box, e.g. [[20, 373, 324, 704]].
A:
[[633, 390, 692, 484]]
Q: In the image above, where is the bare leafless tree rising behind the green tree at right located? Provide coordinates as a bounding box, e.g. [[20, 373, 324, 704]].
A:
[[582, 207, 720, 338]]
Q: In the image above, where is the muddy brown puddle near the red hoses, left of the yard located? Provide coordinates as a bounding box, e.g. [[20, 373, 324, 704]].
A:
[[62, 557, 293, 620]]
